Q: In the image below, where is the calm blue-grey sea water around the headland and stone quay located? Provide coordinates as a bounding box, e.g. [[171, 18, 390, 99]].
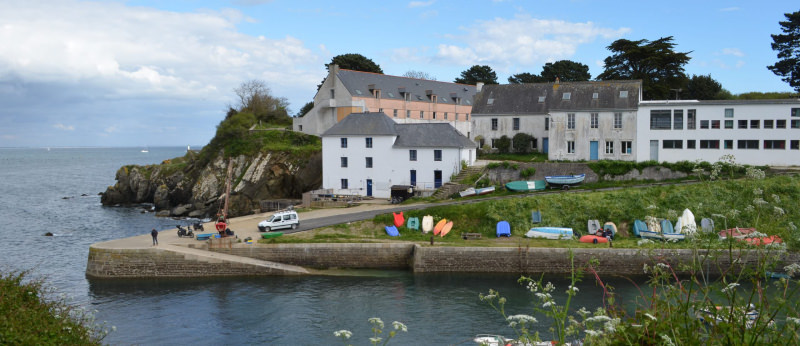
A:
[[0, 147, 637, 345]]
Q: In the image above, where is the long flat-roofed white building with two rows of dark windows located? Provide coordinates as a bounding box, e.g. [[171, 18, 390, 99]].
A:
[[635, 99, 800, 165]]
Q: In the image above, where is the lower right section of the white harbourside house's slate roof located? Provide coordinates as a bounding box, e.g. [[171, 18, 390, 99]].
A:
[[394, 123, 478, 148]]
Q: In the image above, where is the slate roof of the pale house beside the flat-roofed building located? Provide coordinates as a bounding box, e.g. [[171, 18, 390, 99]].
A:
[[472, 80, 642, 116]]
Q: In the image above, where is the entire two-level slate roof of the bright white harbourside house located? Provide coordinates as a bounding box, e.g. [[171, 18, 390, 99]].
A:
[[322, 112, 478, 148]]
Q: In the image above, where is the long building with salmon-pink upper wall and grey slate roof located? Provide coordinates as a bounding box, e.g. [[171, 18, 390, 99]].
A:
[[292, 65, 476, 136]]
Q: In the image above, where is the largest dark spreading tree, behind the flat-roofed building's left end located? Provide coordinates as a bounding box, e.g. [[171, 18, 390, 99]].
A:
[[597, 36, 691, 100]]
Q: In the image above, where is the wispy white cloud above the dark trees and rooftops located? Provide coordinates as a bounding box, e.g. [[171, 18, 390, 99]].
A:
[[437, 16, 630, 71]]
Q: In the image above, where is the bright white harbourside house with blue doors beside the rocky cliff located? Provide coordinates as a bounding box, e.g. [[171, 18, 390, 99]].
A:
[[322, 113, 477, 198]]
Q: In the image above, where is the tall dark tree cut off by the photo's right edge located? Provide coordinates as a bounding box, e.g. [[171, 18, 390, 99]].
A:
[[767, 11, 800, 92]]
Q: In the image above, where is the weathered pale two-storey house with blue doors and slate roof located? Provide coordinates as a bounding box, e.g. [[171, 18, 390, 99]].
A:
[[471, 80, 642, 161]]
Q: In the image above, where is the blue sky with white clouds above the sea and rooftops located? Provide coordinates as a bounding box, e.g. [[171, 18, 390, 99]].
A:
[[0, 0, 800, 147]]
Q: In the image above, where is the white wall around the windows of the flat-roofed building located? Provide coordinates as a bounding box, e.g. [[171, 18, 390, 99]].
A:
[[635, 100, 800, 166]]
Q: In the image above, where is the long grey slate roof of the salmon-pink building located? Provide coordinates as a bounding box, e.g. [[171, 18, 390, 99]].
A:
[[337, 69, 476, 106]]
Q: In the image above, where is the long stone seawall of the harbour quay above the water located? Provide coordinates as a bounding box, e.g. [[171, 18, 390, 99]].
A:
[[86, 243, 800, 278]]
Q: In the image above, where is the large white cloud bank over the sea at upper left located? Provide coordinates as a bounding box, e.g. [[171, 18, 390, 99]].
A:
[[0, 0, 319, 99]]
